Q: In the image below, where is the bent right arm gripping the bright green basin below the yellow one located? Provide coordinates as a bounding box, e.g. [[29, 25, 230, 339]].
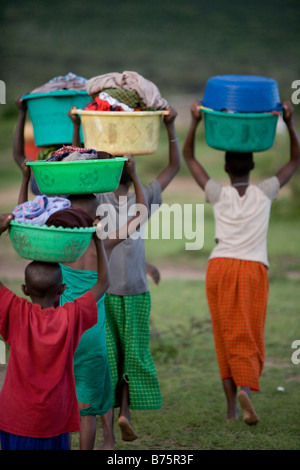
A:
[[104, 154, 148, 259]]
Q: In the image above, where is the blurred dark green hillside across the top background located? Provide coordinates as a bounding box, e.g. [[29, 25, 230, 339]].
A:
[[0, 0, 300, 103]]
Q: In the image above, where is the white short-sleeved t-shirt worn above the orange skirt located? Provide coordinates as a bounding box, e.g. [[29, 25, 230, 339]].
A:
[[205, 176, 280, 267]]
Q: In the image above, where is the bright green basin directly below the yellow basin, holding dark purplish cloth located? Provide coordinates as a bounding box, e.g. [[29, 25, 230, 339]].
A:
[[27, 157, 128, 195]]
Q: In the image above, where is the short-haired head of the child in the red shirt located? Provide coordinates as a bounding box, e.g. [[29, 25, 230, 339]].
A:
[[22, 261, 65, 302]]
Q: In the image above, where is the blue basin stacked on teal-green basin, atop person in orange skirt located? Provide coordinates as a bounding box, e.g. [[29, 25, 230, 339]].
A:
[[202, 75, 282, 152]]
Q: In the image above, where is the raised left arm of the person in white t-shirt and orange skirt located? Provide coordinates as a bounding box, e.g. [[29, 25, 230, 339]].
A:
[[183, 101, 209, 190]]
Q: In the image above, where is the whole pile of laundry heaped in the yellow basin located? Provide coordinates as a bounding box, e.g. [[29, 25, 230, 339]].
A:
[[84, 71, 168, 111]]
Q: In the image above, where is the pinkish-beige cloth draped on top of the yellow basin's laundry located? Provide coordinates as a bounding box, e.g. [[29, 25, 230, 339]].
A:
[[86, 71, 168, 110]]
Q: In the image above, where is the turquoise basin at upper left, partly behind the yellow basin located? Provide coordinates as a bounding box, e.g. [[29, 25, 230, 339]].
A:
[[22, 90, 90, 147]]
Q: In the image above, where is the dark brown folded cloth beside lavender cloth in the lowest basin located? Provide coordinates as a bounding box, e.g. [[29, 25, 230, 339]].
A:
[[46, 208, 93, 228]]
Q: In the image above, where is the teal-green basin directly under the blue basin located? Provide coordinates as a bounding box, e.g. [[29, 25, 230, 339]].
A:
[[203, 108, 278, 152]]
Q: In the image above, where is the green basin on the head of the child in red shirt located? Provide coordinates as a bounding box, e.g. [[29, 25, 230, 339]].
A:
[[9, 220, 96, 263]]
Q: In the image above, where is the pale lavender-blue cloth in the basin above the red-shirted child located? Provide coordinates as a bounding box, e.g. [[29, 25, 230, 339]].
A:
[[12, 194, 71, 225]]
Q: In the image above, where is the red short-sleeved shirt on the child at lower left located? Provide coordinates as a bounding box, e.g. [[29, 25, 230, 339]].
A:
[[0, 286, 97, 438]]
